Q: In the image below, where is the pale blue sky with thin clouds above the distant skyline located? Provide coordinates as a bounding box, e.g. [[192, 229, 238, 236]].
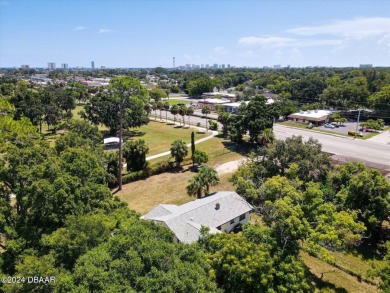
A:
[[0, 0, 390, 68]]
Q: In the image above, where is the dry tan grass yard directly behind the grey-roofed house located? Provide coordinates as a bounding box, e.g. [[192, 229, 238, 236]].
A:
[[115, 165, 234, 214]]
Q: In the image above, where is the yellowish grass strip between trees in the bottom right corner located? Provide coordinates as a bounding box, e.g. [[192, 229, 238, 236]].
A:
[[300, 252, 379, 293]]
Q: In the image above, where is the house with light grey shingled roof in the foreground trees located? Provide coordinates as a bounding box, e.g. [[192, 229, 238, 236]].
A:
[[141, 191, 253, 243]]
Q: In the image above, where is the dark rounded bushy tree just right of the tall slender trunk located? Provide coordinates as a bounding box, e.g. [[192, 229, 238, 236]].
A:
[[123, 139, 149, 172]]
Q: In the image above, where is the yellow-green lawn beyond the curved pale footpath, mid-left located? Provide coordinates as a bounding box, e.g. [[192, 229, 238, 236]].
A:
[[124, 121, 210, 156]]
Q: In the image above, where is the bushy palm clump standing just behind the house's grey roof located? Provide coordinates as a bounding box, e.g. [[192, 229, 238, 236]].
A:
[[187, 167, 219, 198]]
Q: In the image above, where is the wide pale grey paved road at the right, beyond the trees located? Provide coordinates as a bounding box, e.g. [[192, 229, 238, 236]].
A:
[[274, 125, 390, 171]]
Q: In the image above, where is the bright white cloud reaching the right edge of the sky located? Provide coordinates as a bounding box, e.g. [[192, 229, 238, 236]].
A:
[[286, 17, 390, 39]]
